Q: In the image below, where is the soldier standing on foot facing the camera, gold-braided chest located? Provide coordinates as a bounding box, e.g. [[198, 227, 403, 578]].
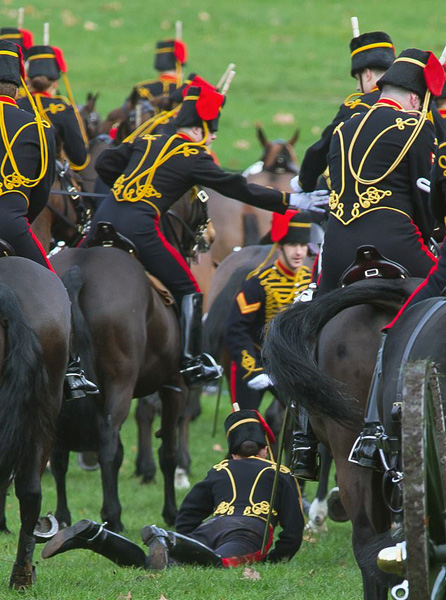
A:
[[226, 210, 311, 409]]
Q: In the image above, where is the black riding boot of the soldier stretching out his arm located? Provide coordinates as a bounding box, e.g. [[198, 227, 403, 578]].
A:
[[181, 292, 223, 387]]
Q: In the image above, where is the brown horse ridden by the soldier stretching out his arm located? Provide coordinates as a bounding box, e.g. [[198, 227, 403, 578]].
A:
[[51, 190, 211, 531]]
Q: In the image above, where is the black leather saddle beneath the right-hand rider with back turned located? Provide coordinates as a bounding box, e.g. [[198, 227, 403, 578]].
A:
[[339, 246, 410, 287]]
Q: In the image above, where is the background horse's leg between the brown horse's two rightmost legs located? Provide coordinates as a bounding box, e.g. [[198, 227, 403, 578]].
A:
[[135, 394, 159, 483]]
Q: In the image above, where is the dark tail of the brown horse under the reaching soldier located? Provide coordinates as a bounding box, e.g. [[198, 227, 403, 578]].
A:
[[62, 265, 97, 381]]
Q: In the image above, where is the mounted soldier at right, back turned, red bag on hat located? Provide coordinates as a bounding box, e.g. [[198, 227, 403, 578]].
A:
[[319, 49, 444, 293]]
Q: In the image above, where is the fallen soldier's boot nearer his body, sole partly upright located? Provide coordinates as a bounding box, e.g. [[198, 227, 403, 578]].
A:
[[141, 525, 222, 569]]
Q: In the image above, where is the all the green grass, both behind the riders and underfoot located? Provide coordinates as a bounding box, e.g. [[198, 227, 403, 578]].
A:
[[0, 0, 446, 600]]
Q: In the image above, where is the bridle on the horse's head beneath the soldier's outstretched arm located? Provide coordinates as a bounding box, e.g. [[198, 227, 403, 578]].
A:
[[162, 189, 210, 259]]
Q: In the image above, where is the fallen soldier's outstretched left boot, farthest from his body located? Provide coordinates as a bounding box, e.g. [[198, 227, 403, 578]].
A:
[[42, 519, 147, 567]]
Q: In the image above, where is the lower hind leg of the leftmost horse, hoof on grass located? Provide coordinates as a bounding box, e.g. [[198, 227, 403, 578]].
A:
[[9, 449, 42, 589]]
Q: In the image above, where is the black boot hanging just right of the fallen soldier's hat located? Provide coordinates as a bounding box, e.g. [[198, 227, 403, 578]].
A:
[[290, 408, 319, 481]]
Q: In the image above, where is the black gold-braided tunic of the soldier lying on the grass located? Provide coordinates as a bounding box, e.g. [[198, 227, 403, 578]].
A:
[[176, 456, 304, 562]]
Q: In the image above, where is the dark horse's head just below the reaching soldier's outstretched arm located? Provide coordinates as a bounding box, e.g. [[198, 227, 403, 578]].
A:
[[163, 187, 215, 258]]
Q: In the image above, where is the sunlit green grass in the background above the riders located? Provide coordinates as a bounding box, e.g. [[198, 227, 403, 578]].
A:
[[0, 0, 446, 169]]
